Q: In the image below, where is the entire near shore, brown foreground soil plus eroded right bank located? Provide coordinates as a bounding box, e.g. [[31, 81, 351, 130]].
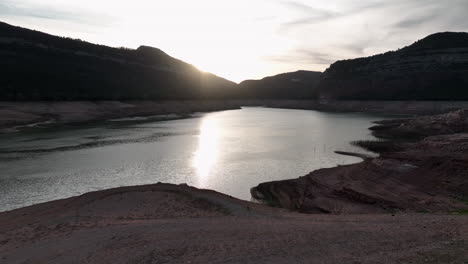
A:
[[0, 110, 468, 264]]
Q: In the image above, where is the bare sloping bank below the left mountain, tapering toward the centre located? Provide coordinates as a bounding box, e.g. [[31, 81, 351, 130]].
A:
[[0, 101, 240, 132]]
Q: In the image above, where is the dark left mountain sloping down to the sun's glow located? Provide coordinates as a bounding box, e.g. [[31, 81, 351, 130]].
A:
[[0, 23, 236, 101]]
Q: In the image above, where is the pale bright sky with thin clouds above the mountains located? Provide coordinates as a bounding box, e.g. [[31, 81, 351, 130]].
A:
[[0, 0, 468, 82]]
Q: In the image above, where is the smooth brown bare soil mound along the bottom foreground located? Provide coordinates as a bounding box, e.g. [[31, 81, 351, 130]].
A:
[[0, 184, 468, 264]]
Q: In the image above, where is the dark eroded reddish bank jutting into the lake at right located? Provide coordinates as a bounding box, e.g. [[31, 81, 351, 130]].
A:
[[251, 110, 468, 214]]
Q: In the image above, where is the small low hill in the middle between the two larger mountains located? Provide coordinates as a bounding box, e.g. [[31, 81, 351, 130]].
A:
[[239, 71, 321, 99]]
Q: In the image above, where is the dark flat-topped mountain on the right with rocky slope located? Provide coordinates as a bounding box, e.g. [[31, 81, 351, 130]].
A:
[[319, 32, 468, 100]]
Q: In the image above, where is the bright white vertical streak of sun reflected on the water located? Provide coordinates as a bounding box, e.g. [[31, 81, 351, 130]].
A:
[[192, 118, 220, 188]]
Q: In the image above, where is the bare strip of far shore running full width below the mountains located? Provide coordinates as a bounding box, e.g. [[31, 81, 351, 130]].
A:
[[0, 99, 468, 133]]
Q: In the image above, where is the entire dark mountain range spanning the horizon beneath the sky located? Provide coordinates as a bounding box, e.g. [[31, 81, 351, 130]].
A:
[[0, 22, 468, 101]]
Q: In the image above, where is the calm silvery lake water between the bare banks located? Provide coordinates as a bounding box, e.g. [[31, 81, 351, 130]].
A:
[[0, 107, 384, 211]]
